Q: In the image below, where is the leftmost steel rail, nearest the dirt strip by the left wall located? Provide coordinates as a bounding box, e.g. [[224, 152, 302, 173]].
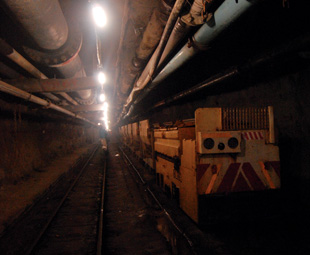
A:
[[25, 144, 99, 255]]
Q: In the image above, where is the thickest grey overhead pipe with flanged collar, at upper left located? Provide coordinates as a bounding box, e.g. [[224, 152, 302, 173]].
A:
[[4, 0, 94, 104]]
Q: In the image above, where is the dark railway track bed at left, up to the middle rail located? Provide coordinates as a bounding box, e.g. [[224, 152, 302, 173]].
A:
[[0, 146, 106, 254]]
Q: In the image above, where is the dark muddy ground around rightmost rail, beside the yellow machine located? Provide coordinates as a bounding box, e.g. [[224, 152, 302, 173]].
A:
[[119, 147, 225, 255]]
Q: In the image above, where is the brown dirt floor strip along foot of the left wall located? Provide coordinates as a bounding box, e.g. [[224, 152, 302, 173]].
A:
[[0, 145, 92, 236]]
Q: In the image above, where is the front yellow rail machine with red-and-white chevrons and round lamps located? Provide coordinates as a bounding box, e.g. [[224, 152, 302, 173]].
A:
[[154, 107, 280, 223]]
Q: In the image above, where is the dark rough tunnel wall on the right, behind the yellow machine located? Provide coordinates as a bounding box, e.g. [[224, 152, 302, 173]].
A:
[[151, 65, 310, 205]]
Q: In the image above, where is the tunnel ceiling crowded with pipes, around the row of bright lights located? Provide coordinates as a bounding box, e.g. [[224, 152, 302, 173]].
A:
[[0, 0, 309, 127]]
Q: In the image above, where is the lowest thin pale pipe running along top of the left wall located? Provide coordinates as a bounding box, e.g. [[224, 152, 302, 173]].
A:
[[0, 81, 96, 126]]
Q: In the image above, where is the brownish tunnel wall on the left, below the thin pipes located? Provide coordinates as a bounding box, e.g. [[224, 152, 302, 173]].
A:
[[0, 99, 98, 186]]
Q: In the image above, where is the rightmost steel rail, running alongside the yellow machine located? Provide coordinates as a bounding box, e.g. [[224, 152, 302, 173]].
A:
[[119, 146, 196, 254]]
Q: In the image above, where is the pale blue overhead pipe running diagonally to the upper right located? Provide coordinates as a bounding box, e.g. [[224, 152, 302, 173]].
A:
[[124, 0, 258, 117]]
